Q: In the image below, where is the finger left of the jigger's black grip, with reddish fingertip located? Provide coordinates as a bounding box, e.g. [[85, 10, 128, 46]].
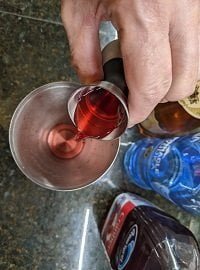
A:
[[61, 0, 103, 83]]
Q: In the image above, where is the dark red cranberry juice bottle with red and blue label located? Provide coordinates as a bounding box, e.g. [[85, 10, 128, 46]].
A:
[[101, 193, 200, 270]]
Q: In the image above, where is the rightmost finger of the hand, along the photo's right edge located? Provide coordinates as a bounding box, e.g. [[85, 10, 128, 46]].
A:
[[165, 1, 199, 101]]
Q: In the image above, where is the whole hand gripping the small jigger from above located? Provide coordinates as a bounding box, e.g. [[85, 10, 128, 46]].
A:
[[61, 0, 200, 127]]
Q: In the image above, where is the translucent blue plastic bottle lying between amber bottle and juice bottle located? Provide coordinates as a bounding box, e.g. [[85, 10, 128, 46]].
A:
[[124, 133, 200, 215]]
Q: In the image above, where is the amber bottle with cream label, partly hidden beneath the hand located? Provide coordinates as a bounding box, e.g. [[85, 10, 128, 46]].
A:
[[139, 81, 200, 137]]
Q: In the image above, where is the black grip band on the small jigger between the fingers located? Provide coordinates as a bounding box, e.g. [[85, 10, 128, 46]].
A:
[[103, 58, 128, 97]]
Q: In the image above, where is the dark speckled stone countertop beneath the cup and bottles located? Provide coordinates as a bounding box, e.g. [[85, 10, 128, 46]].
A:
[[0, 1, 200, 270]]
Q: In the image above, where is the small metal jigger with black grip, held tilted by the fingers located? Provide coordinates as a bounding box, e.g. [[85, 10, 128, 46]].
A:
[[67, 39, 129, 140]]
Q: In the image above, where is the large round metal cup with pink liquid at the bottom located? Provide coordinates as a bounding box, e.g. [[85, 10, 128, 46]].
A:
[[9, 82, 119, 190]]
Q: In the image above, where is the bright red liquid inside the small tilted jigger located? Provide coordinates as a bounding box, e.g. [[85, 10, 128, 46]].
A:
[[74, 88, 125, 138]]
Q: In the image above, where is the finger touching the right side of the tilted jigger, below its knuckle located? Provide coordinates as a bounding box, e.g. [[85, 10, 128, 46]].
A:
[[119, 26, 171, 127]]
